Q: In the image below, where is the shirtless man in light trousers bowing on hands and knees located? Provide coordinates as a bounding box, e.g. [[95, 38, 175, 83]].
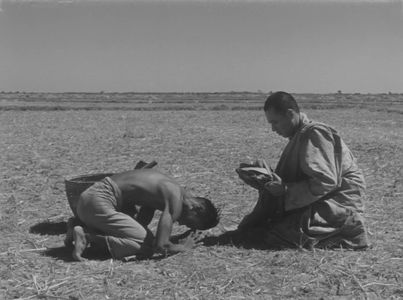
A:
[[73, 169, 219, 261]]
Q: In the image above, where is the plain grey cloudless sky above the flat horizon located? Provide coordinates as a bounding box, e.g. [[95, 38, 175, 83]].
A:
[[0, 0, 403, 93]]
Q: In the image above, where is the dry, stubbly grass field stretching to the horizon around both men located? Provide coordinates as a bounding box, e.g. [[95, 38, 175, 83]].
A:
[[0, 93, 403, 300]]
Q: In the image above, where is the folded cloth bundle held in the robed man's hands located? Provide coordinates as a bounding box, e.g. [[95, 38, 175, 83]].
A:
[[235, 160, 273, 191]]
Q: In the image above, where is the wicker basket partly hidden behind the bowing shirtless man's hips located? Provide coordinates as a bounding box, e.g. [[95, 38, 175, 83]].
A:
[[64, 173, 113, 217]]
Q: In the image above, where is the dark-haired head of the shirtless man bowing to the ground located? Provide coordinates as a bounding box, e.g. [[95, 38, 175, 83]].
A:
[[178, 197, 220, 230]]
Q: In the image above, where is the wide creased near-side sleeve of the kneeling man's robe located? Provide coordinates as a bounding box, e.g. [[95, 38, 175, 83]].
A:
[[284, 127, 338, 211]]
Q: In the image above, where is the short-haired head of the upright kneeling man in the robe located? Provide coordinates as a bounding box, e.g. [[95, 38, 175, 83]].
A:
[[264, 92, 300, 137]]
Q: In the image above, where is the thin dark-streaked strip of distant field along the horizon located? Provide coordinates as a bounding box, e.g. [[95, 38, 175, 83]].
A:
[[0, 92, 403, 113]]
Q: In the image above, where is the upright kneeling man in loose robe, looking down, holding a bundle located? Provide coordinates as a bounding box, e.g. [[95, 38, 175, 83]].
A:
[[237, 92, 368, 249]]
